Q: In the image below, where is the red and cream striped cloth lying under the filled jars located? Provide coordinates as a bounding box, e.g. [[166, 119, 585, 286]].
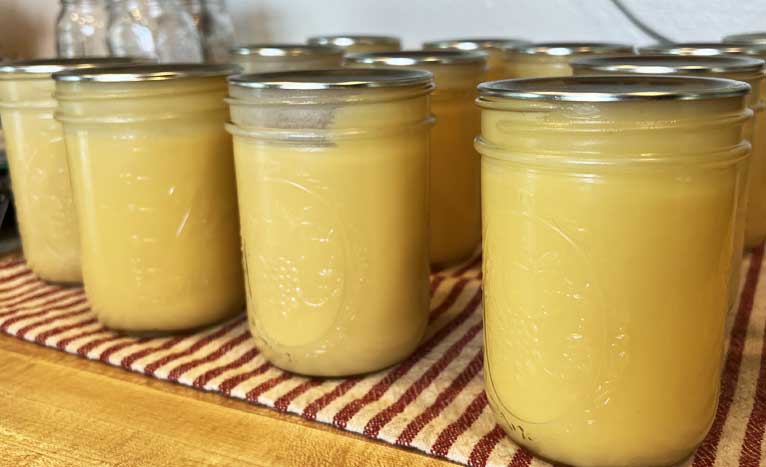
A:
[[0, 249, 766, 467]]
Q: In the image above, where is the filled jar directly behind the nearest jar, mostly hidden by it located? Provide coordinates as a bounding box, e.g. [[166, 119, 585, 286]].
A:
[[571, 55, 766, 308]]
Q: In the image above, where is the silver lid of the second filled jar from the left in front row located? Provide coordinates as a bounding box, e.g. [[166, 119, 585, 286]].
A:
[[53, 63, 241, 83]]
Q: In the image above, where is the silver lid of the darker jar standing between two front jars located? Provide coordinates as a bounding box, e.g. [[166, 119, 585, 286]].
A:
[[346, 50, 487, 66]]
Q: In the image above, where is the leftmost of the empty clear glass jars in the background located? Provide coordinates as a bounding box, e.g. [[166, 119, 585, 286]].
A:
[[56, 0, 109, 58]]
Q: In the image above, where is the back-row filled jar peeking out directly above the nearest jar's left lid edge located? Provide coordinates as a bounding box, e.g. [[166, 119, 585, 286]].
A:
[[503, 42, 634, 78]]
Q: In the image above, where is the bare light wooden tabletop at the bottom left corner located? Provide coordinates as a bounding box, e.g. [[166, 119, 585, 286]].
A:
[[0, 335, 454, 467]]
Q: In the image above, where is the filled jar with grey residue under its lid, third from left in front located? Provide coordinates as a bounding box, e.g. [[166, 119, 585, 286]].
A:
[[227, 70, 433, 376]]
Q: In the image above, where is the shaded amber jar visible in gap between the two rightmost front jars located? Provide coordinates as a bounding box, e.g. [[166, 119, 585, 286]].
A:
[[346, 50, 486, 268]]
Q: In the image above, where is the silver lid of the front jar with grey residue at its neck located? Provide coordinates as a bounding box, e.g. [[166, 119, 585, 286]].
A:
[[229, 68, 433, 91]]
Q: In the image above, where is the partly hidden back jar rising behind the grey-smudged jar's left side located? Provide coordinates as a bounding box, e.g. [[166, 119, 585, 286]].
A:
[[231, 44, 343, 73]]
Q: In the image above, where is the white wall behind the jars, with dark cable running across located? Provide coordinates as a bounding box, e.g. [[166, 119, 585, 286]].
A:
[[0, 0, 766, 57]]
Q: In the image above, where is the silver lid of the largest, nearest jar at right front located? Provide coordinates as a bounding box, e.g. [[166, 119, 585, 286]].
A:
[[478, 75, 750, 102]]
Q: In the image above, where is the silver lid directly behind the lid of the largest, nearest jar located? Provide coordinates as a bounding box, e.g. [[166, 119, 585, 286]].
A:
[[570, 55, 764, 75]]
